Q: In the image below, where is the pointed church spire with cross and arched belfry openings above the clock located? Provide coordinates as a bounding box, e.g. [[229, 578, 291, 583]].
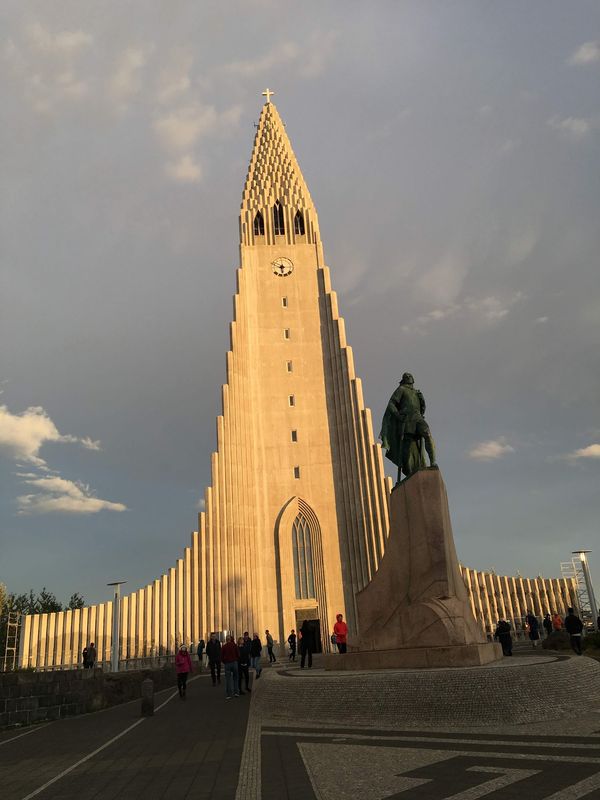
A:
[[240, 89, 320, 245]]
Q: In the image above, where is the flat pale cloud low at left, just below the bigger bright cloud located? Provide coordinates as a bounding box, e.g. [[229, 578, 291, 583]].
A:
[[17, 475, 127, 515]]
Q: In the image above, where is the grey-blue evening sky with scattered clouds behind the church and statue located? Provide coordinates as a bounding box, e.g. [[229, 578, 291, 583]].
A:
[[0, 0, 600, 602]]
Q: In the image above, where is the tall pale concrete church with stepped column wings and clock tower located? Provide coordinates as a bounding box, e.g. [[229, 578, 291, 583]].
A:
[[19, 90, 574, 668]]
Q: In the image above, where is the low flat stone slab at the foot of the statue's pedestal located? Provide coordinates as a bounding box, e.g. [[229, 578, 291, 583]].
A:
[[323, 642, 502, 670]]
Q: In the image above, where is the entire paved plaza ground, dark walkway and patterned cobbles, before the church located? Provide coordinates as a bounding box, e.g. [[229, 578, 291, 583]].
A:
[[0, 651, 600, 800]]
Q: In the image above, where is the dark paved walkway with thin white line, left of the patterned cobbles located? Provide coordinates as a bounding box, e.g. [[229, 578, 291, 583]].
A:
[[0, 676, 250, 800]]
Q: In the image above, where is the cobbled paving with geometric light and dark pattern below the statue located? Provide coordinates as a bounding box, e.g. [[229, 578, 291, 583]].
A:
[[236, 653, 600, 800]]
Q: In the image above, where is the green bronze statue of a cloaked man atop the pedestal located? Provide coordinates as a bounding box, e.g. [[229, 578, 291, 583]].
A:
[[379, 372, 437, 483]]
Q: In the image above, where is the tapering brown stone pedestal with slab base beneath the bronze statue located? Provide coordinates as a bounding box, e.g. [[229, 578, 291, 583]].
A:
[[325, 468, 502, 669]]
